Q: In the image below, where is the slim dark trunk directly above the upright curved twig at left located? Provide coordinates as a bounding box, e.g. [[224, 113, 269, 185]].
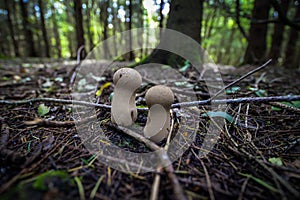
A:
[[74, 0, 86, 59]]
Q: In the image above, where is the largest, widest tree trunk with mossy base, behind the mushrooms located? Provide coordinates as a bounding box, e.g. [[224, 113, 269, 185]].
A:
[[145, 0, 204, 67]]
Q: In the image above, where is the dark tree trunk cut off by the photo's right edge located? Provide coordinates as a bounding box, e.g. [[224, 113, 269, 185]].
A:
[[283, 5, 300, 69]]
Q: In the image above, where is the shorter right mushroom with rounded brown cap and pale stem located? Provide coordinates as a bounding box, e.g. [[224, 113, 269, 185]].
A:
[[144, 85, 174, 142]]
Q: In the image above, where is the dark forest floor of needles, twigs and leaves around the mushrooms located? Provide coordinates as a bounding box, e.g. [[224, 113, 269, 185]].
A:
[[0, 59, 300, 199]]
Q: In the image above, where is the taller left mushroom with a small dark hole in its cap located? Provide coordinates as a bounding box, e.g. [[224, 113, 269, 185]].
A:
[[111, 68, 142, 126]]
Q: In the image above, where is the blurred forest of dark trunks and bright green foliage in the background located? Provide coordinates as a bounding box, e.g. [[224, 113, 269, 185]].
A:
[[0, 0, 300, 69]]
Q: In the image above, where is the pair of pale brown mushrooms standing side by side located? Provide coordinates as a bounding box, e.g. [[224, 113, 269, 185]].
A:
[[111, 68, 174, 142]]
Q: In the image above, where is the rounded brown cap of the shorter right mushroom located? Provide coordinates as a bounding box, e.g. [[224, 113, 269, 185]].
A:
[[145, 85, 174, 108]]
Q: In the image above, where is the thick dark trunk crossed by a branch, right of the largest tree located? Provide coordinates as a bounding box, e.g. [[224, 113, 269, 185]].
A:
[[244, 0, 270, 64]]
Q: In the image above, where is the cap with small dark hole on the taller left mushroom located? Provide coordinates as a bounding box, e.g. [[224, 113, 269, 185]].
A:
[[113, 68, 142, 87]]
